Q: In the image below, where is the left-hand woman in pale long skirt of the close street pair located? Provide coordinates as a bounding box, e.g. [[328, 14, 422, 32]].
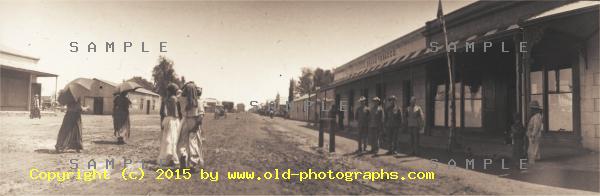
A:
[[156, 83, 180, 165]]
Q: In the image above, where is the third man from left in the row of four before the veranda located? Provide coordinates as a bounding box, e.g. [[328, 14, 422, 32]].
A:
[[384, 95, 402, 155]]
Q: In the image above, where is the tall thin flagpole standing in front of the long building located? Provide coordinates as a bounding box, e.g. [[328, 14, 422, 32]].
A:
[[438, 0, 456, 152]]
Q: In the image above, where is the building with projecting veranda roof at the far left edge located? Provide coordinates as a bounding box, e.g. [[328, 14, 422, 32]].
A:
[[0, 50, 58, 111]]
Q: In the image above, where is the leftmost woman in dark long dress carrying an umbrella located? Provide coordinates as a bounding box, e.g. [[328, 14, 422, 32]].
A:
[[54, 91, 83, 153]]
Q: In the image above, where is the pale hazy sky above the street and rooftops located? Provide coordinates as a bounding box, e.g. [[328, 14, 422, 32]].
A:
[[0, 0, 473, 105]]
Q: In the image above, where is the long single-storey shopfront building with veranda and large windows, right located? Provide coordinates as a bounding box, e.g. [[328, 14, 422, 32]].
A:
[[326, 1, 600, 154]]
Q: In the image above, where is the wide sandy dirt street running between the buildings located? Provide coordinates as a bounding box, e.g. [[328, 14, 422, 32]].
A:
[[0, 113, 591, 195]]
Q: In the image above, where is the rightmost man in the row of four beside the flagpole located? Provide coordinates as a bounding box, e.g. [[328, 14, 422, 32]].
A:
[[406, 96, 425, 155]]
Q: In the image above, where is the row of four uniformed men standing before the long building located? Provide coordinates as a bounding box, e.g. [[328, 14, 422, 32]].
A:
[[355, 95, 425, 155]]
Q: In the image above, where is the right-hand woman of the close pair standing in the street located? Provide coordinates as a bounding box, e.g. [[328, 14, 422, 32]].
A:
[[177, 81, 204, 172]]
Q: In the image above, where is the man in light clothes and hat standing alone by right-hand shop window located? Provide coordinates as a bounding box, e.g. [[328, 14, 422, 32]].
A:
[[527, 100, 543, 164]]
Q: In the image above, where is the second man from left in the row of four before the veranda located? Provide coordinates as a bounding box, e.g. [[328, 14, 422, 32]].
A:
[[369, 97, 384, 154]]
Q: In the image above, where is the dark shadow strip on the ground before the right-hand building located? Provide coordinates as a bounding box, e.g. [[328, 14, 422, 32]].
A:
[[298, 121, 600, 192]]
